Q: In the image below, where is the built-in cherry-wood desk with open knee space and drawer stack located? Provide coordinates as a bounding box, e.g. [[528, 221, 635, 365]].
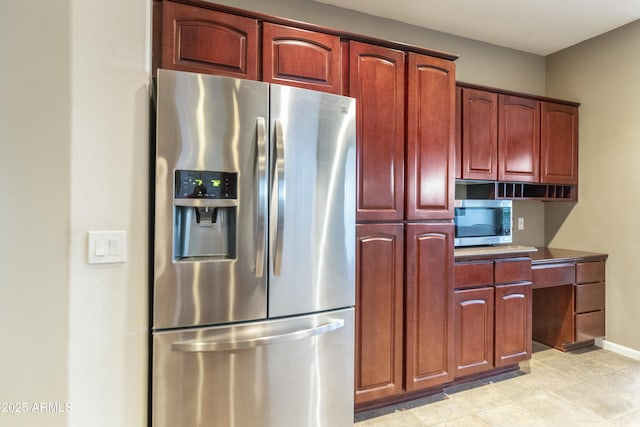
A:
[[529, 248, 607, 351]]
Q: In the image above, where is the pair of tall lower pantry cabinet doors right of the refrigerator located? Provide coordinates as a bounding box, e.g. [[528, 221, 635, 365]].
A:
[[355, 222, 454, 409]]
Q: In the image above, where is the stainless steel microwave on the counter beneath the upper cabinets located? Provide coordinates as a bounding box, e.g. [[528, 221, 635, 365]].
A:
[[454, 200, 512, 246]]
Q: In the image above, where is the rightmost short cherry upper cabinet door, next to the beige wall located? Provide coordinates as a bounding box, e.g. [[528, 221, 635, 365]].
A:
[[540, 102, 578, 184]]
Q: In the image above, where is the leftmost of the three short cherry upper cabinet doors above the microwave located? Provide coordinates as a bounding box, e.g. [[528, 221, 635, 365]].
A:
[[461, 88, 498, 181]]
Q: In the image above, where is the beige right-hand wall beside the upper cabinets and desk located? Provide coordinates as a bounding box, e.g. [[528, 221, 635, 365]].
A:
[[546, 21, 640, 351]]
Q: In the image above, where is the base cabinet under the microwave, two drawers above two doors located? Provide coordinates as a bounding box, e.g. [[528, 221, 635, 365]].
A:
[[454, 258, 532, 378]]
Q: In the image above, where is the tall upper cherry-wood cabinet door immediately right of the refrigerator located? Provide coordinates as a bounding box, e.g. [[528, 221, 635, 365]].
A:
[[349, 42, 405, 221]]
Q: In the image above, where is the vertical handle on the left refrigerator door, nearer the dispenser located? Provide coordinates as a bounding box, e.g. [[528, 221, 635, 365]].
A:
[[256, 117, 268, 277]]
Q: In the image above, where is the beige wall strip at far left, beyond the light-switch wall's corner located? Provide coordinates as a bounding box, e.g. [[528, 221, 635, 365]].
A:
[[0, 0, 71, 427]]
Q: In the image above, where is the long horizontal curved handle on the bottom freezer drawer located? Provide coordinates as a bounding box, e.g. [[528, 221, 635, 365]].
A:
[[171, 319, 344, 353]]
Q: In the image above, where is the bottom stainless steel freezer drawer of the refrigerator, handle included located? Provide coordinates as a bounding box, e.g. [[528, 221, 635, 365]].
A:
[[152, 309, 354, 427]]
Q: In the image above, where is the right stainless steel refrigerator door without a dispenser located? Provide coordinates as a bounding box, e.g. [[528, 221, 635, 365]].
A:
[[269, 85, 356, 317]]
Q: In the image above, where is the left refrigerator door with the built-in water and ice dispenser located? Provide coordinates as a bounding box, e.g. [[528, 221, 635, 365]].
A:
[[153, 70, 269, 330]]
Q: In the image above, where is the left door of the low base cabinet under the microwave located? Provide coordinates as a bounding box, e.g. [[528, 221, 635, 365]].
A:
[[454, 287, 493, 377]]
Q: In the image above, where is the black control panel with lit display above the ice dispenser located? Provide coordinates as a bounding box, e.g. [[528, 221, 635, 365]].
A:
[[175, 170, 238, 199]]
